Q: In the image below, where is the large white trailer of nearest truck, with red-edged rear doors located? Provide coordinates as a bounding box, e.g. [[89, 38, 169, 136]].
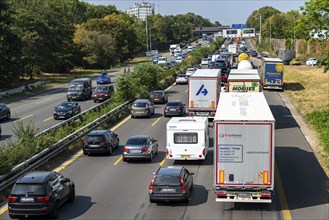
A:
[[213, 92, 275, 203]]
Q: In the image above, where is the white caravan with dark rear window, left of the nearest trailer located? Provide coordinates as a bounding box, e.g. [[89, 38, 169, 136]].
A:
[[166, 117, 209, 160]]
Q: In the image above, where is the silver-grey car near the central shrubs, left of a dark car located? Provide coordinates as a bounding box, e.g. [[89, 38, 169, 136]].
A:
[[130, 99, 154, 118]]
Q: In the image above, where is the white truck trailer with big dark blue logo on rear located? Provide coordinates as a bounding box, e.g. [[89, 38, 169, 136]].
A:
[[188, 69, 221, 118]]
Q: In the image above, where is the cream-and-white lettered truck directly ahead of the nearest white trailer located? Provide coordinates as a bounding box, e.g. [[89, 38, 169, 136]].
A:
[[226, 74, 262, 92]]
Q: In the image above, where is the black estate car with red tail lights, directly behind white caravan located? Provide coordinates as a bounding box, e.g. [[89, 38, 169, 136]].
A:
[[149, 166, 194, 203]]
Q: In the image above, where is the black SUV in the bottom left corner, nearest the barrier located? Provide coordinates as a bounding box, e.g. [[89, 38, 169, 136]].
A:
[[8, 171, 75, 218]]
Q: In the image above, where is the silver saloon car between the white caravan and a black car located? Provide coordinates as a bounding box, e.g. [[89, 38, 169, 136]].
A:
[[122, 135, 158, 161]]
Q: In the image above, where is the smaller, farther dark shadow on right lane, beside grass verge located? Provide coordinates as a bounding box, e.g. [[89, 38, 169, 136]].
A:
[[270, 105, 299, 129]]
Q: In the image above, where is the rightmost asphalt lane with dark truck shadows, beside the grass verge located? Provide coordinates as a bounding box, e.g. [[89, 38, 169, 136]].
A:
[[265, 92, 329, 219]]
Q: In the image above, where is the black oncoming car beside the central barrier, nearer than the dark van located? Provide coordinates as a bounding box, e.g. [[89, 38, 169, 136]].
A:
[[54, 102, 81, 119]]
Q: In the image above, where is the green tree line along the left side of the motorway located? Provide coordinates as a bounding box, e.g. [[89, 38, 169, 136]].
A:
[[0, 0, 215, 87]]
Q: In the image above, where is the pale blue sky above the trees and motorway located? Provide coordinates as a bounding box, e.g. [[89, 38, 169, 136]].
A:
[[82, 0, 306, 25]]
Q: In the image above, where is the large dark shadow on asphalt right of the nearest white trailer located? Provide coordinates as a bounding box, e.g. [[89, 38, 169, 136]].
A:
[[275, 146, 329, 210]]
